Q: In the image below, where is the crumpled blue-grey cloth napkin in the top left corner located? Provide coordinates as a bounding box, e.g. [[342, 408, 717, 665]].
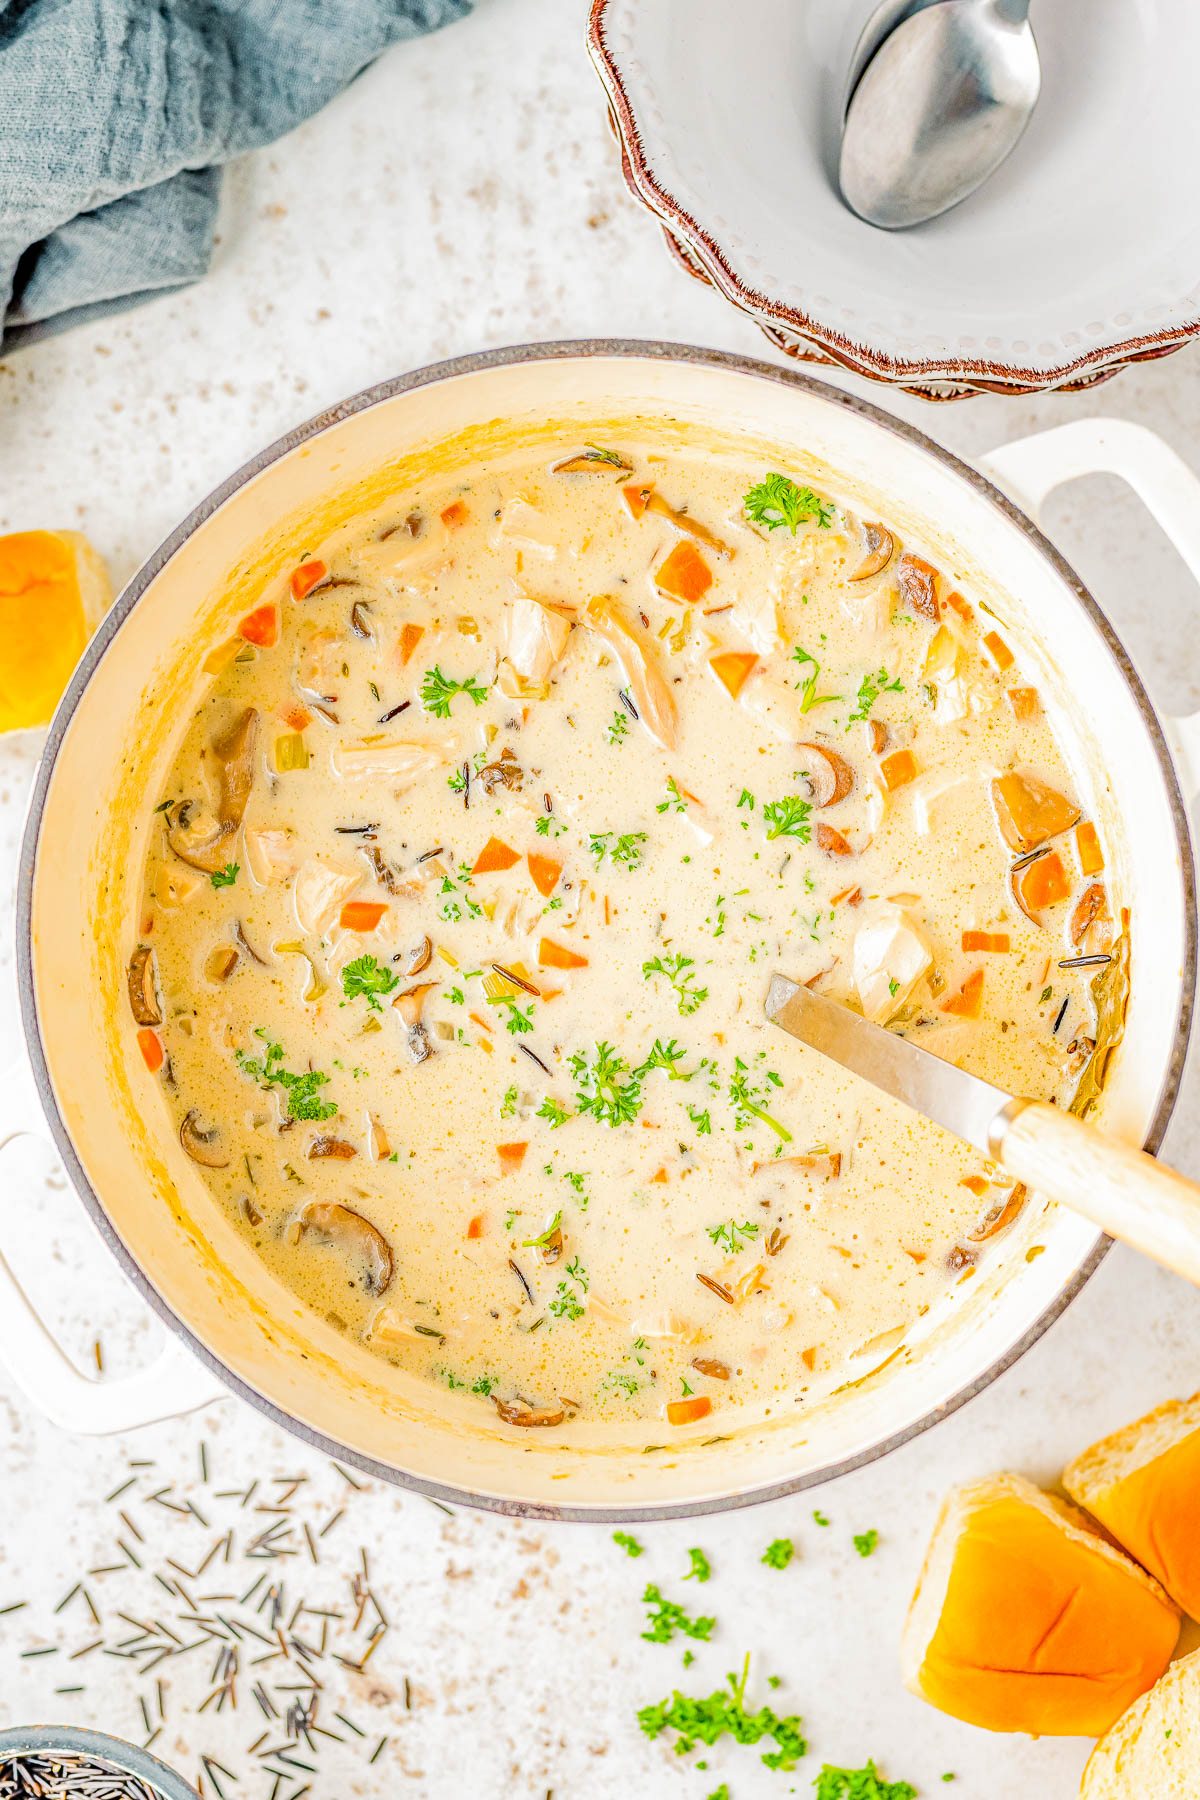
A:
[[0, 0, 471, 353]]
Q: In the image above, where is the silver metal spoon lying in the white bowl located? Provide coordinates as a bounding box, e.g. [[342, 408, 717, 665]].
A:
[[838, 0, 1042, 230]]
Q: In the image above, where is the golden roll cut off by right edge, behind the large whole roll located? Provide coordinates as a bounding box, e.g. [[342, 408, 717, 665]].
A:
[[1063, 1393, 1200, 1618]]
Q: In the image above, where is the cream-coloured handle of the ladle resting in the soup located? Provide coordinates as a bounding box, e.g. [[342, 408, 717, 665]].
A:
[[991, 1100, 1200, 1287]]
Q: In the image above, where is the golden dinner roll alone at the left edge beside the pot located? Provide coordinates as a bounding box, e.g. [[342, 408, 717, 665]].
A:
[[0, 531, 112, 731]]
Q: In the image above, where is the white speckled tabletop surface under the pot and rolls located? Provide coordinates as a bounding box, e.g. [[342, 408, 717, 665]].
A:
[[0, 0, 1200, 1800]]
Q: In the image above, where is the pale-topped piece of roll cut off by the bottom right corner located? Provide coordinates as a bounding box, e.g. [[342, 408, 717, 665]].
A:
[[1079, 1651, 1200, 1800]]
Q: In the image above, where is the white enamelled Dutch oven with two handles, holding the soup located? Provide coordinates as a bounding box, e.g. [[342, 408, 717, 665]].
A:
[[0, 342, 1200, 1519]]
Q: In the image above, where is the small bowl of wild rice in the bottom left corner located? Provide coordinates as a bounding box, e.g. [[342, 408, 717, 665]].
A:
[[0, 1724, 198, 1800]]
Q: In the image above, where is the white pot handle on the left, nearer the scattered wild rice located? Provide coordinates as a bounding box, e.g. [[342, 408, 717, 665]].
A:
[[0, 1058, 228, 1436]]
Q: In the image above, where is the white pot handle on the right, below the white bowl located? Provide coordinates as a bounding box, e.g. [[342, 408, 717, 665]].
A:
[[977, 419, 1200, 799]]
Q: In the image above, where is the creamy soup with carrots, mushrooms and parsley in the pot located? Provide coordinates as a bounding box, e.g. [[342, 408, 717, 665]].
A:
[[130, 439, 1124, 1442]]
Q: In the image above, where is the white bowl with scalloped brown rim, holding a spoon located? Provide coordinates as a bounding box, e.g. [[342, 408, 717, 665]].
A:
[[588, 0, 1200, 392]]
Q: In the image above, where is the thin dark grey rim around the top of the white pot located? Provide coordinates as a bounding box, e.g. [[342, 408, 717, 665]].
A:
[[16, 338, 1196, 1525]]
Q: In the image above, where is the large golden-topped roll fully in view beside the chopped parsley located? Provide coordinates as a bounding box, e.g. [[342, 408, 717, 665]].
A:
[[901, 1474, 1180, 1737]]
